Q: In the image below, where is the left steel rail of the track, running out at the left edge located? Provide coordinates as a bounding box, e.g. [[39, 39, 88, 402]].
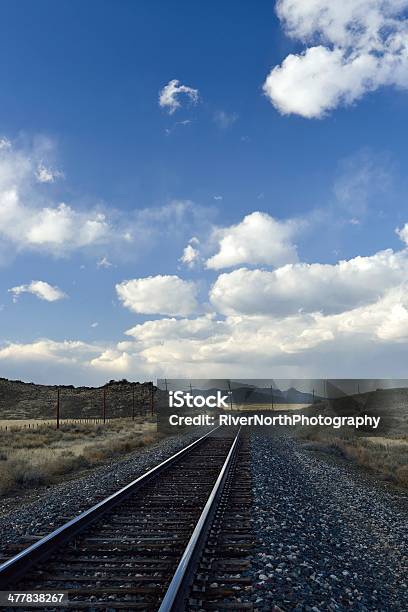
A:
[[0, 426, 220, 590]]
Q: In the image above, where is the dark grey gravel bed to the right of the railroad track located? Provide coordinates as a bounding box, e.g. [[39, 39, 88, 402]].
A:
[[252, 434, 408, 612]]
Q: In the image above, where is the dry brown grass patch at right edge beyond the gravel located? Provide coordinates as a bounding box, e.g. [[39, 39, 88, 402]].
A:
[[298, 428, 408, 487]]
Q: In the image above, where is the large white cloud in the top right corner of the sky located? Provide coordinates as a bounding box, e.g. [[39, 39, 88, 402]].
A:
[[264, 0, 408, 118]]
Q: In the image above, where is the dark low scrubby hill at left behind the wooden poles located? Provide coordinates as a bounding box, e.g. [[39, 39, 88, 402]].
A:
[[0, 378, 158, 419]]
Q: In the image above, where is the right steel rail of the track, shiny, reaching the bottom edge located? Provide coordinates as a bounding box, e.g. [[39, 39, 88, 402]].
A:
[[158, 427, 241, 612]]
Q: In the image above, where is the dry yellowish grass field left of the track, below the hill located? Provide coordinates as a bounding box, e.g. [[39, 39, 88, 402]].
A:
[[0, 417, 158, 495]]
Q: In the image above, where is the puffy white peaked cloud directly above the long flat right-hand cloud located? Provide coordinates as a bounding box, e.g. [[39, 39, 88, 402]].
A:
[[206, 212, 301, 270]]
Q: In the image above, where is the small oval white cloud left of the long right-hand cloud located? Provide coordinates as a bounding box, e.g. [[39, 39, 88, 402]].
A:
[[116, 275, 198, 316]]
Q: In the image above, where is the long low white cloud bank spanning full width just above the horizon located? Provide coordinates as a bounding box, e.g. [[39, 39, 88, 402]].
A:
[[0, 284, 408, 383]]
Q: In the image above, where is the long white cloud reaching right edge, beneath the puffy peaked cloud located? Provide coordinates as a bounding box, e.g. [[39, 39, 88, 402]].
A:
[[210, 249, 408, 316]]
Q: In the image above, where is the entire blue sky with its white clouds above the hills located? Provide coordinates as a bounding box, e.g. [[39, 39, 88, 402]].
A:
[[0, 0, 408, 384]]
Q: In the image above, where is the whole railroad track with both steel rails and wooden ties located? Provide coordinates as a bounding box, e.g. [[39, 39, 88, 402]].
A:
[[0, 428, 254, 612]]
